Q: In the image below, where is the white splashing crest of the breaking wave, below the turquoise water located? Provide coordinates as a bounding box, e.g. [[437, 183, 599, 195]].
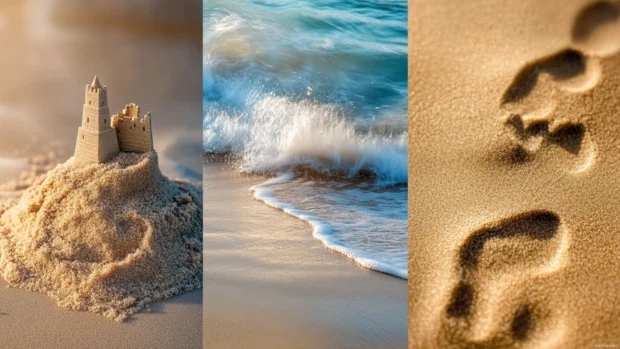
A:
[[204, 94, 408, 184]]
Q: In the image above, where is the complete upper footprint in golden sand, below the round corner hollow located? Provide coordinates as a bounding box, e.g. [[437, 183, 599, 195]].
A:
[[500, 49, 600, 173]]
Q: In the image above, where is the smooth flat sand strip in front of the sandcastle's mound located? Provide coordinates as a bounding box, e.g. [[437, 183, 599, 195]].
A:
[[0, 280, 202, 349]]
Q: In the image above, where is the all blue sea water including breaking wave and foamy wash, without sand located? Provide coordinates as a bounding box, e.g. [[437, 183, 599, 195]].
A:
[[203, 0, 407, 278]]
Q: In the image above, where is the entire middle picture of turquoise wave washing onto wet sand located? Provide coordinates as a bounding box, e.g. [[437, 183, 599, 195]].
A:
[[203, 0, 407, 348]]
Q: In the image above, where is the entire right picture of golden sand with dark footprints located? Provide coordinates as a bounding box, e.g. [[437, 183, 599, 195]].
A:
[[409, 0, 620, 348]]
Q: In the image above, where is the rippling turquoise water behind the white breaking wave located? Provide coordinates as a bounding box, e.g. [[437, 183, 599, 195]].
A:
[[204, 1, 407, 119]]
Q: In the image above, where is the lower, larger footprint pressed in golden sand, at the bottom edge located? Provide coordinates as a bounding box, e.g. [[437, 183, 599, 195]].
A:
[[443, 211, 569, 348]]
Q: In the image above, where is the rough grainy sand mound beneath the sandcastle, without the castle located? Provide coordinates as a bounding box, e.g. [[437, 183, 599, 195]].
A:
[[0, 152, 202, 321]]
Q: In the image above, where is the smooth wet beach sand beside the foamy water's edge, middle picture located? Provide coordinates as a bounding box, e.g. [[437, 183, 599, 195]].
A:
[[203, 164, 407, 349]]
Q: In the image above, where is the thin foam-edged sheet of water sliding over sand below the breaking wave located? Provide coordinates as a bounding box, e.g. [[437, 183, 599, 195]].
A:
[[250, 173, 407, 279]]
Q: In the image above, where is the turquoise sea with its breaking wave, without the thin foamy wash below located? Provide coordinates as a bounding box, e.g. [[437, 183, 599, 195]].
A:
[[203, 0, 407, 184]]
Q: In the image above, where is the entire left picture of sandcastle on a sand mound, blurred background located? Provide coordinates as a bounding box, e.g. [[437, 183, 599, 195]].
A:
[[0, 0, 203, 349]]
